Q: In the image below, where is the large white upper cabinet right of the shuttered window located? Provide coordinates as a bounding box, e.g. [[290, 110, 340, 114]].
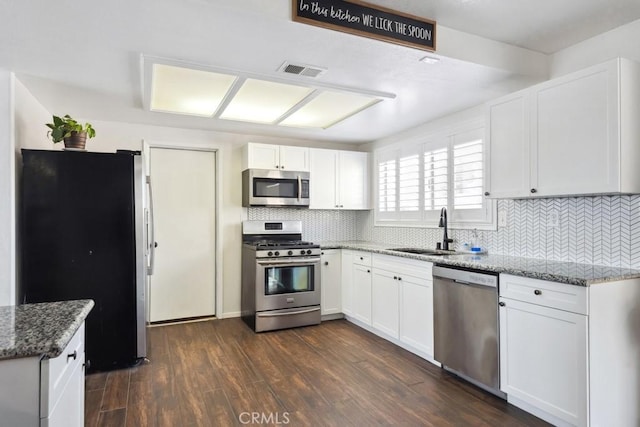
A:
[[486, 58, 640, 198]]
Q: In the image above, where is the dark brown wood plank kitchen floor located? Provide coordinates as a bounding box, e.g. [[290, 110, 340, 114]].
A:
[[85, 319, 547, 427]]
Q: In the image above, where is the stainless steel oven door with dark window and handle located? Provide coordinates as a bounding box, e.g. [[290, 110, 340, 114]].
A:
[[256, 257, 320, 311]]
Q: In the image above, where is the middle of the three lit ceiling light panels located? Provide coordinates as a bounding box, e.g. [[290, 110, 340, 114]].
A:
[[220, 79, 313, 123]]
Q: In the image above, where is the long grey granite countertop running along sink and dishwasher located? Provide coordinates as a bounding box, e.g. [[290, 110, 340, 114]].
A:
[[320, 241, 640, 286]]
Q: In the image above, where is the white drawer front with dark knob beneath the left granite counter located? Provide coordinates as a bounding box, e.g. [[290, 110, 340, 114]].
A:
[[40, 323, 84, 418]]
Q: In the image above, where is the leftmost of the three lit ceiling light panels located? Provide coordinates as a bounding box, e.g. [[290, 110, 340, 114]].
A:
[[150, 64, 237, 117]]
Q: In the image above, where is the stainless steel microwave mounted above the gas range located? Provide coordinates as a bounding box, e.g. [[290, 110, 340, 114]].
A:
[[242, 169, 309, 207]]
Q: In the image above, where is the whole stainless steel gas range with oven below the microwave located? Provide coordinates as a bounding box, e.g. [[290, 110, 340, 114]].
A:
[[241, 221, 320, 332]]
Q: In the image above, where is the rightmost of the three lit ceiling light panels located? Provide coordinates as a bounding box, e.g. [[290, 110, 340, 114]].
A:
[[279, 91, 381, 129]]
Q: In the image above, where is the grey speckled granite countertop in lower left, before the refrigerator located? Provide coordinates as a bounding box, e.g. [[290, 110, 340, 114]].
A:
[[0, 300, 94, 360]]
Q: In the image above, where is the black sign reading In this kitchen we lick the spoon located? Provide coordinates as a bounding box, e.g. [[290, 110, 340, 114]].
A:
[[292, 0, 436, 52]]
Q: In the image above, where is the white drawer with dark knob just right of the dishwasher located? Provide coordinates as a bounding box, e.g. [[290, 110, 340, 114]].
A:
[[500, 274, 589, 315]]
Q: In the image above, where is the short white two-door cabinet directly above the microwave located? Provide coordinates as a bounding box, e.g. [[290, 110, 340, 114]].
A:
[[242, 142, 309, 172]]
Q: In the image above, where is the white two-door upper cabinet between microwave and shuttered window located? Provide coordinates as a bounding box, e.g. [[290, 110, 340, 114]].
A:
[[309, 148, 370, 210]]
